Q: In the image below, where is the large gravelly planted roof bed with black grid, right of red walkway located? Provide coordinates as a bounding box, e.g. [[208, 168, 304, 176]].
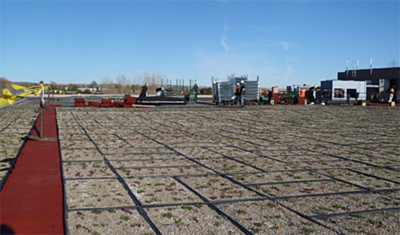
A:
[[57, 106, 400, 234]]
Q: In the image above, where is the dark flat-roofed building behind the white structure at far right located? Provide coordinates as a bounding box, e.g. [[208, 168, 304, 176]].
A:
[[338, 67, 400, 102]]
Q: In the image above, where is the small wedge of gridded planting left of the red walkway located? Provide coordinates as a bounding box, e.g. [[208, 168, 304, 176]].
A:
[[0, 103, 38, 190]]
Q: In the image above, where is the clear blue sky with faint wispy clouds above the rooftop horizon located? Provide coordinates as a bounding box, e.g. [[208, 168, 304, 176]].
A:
[[0, 0, 400, 87]]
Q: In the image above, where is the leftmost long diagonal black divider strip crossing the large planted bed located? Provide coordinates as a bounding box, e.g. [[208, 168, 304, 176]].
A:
[[71, 112, 161, 234]]
